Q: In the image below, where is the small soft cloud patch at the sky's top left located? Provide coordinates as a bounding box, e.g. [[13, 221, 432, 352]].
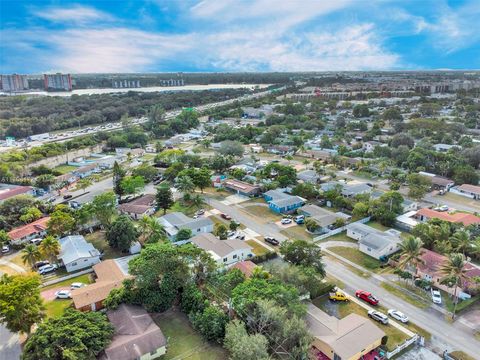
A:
[[34, 5, 113, 24]]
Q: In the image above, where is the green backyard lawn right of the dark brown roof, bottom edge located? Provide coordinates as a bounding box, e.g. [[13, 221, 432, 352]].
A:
[[153, 310, 227, 360]]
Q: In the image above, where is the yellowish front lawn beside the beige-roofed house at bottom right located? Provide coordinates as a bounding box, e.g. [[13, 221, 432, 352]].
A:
[[312, 296, 408, 351]]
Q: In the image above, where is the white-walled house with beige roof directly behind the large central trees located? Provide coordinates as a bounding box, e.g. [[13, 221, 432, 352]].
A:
[[191, 233, 253, 266]]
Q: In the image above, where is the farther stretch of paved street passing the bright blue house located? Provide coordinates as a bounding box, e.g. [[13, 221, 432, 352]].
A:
[[205, 197, 287, 242]]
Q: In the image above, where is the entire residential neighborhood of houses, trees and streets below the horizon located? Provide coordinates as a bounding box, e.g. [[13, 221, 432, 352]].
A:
[[0, 72, 480, 360]]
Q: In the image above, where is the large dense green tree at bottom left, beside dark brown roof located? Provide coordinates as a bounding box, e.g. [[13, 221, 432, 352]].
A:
[[22, 309, 113, 360]]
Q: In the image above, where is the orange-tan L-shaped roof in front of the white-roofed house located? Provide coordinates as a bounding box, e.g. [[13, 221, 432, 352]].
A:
[[72, 259, 128, 309]]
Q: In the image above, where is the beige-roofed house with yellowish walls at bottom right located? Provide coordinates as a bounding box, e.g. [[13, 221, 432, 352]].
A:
[[305, 303, 385, 360]]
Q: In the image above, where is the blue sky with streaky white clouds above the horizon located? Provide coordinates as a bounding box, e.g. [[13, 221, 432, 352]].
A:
[[0, 0, 480, 73]]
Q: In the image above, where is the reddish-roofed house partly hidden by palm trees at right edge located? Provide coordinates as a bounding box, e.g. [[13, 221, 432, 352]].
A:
[[416, 249, 480, 298]]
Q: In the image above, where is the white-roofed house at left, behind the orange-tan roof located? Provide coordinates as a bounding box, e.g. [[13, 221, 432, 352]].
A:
[[57, 235, 101, 272]]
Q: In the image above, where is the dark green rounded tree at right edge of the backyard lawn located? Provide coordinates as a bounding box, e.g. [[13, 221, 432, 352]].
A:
[[190, 305, 228, 344]]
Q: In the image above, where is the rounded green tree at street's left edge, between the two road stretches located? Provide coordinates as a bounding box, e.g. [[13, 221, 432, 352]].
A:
[[280, 239, 325, 276]]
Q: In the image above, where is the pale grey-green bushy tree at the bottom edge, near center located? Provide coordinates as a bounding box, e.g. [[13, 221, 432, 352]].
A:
[[224, 320, 270, 360]]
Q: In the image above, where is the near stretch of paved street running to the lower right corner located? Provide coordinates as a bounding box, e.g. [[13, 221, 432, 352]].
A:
[[324, 258, 480, 359]]
